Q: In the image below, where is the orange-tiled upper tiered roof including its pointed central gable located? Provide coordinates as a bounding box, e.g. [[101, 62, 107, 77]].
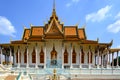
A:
[[19, 8, 86, 43]]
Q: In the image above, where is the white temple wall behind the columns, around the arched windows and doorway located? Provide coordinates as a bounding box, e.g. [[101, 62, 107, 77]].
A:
[[14, 40, 95, 65]]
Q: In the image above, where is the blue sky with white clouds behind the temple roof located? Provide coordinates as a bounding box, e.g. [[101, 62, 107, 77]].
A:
[[0, 0, 120, 48]]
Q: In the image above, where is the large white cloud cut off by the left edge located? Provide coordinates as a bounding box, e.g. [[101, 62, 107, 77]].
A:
[[0, 16, 16, 37]]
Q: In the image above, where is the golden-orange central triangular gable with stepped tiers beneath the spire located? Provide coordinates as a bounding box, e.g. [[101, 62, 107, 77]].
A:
[[45, 10, 64, 38]]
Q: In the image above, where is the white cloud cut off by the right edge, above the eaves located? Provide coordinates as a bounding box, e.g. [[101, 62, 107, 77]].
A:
[[107, 19, 120, 33]]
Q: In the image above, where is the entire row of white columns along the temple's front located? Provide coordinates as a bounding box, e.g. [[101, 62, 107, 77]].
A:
[[0, 44, 119, 68]]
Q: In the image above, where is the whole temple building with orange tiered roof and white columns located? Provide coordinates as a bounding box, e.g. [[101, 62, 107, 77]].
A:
[[0, 0, 120, 79]]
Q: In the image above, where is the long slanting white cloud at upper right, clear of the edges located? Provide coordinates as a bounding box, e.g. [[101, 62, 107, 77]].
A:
[[86, 5, 112, 22]]
